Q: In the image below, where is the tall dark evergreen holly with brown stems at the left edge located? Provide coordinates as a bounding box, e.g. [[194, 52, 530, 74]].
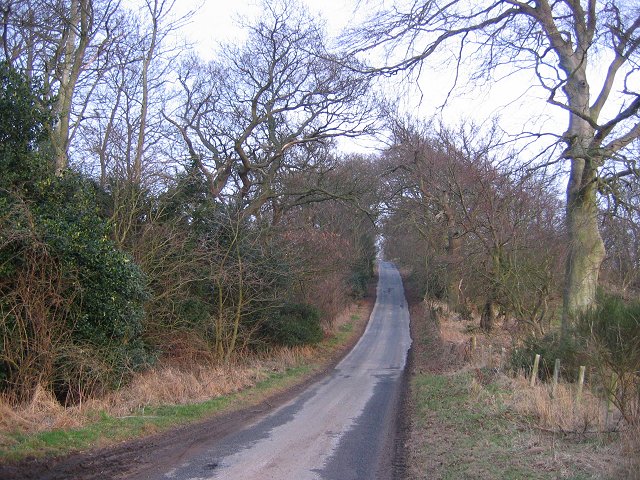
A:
[[0, 63, 151, 402]]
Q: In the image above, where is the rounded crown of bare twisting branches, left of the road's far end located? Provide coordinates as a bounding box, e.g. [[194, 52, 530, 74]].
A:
[[168, 3, 376, 218]]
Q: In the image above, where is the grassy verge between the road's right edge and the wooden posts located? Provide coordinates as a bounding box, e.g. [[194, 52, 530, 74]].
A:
[[407, 305, 624, 480]]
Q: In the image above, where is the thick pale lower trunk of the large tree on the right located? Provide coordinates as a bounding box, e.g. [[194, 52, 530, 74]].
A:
[[562, 158, 605, 335]]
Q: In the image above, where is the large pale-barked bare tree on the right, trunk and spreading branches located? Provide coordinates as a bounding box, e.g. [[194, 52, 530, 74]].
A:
[[350, 0, 640, 327]]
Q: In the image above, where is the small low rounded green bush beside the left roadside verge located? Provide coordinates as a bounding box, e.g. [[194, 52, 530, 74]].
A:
[[262, 303, 324, 347]]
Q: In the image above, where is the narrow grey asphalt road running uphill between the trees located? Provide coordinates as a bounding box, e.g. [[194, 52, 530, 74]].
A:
[[131, 262, 411, 480]]
